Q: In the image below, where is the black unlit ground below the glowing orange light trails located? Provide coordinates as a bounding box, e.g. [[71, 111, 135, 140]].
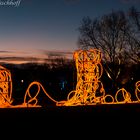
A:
[[0, 104, 140, 140]]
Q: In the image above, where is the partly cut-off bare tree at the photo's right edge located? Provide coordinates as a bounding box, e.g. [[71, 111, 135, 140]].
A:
[[126, 7, 140, 64]]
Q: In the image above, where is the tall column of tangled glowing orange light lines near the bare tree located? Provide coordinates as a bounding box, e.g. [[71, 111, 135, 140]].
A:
[[57, 49, 105, 106]]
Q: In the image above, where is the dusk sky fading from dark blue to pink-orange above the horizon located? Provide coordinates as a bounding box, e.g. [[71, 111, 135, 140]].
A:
[[0, 0, 140, 61]]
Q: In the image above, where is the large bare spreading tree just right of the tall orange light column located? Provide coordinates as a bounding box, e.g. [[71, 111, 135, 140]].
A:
[[78, 11, 129, 88]]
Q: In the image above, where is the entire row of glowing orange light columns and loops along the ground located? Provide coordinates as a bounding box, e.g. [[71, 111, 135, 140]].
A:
[[0, 49, 140, 108]]
